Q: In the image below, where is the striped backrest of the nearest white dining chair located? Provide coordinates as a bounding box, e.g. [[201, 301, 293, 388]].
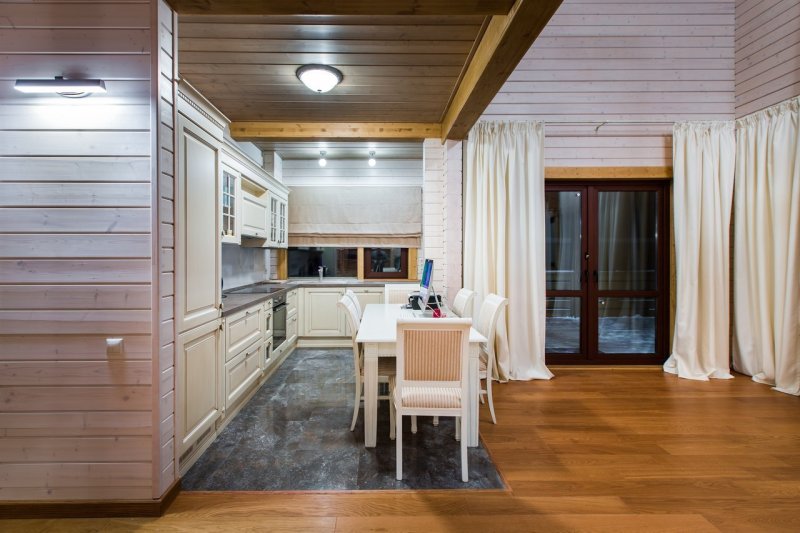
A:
[[397, 318, 472, 388]]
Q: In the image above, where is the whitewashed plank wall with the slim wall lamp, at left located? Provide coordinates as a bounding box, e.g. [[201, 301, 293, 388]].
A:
[[0, 0, 153, 500]]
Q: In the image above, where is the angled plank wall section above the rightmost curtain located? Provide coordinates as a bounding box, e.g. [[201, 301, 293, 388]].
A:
[[736, 0, 800, 117]]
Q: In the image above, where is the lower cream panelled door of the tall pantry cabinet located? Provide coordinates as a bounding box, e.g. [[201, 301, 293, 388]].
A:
[[175, 320, 222, 454]]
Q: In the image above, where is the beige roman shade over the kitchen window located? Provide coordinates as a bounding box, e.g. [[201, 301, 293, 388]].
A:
[[289, 186, 422, 248]]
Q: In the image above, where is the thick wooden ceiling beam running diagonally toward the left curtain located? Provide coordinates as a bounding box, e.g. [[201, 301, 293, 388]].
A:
[[441, 0, 562, 141]]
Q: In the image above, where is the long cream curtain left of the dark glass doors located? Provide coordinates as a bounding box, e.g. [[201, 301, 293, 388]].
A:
[[464, 122, 553, 380]]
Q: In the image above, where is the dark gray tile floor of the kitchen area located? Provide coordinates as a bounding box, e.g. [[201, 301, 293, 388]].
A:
[[182, 349, 505, 490]]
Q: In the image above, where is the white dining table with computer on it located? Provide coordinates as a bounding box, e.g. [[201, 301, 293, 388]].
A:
[[356, 304, 486, 448]]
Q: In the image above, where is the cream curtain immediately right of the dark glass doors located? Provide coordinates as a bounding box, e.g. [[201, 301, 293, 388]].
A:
[[664, 122, 735, 380]]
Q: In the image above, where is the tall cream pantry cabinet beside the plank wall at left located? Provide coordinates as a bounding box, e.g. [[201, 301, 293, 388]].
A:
[[175, 84, 227, 464]]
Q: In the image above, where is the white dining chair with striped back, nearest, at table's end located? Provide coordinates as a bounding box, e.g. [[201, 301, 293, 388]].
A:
[[390, 318, 472, 482]]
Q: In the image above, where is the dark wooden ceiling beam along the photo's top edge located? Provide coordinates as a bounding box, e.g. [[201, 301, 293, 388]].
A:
[[167, 0, 514, 16]]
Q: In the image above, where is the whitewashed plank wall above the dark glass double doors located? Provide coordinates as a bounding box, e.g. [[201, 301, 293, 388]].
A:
[[482, 0, 734, 167]]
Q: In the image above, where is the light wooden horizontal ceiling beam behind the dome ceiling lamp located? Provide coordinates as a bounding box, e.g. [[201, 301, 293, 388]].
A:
[[230, 121, 441, 142]]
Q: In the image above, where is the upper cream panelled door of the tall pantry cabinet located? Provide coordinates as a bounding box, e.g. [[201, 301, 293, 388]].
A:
[[175, 115, 221, 332]]
